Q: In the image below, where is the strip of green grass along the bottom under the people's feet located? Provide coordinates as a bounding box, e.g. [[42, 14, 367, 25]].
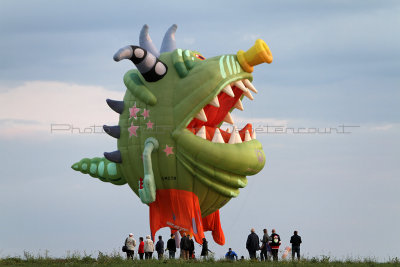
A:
[[0, 252, 400, 267]]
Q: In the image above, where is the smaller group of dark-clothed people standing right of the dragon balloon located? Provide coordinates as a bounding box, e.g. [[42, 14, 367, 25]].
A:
[[246, 228, 302, 261]]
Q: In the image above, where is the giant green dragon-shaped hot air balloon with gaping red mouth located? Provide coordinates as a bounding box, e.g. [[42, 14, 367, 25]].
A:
[[72, 25, 272, 245]]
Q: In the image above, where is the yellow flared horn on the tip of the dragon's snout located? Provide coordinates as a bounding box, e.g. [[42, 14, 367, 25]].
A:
[[236, 39, 273, 72]]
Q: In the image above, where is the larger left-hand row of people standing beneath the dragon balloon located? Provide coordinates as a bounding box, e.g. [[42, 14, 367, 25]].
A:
[[122, 233, 209, 260]]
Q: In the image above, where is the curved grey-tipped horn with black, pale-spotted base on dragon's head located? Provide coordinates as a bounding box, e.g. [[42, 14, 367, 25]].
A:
[[114, 45, 168, 82]]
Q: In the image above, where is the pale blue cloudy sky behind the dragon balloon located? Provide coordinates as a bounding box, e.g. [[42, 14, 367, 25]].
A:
[[0, 0, 400, 261]]
